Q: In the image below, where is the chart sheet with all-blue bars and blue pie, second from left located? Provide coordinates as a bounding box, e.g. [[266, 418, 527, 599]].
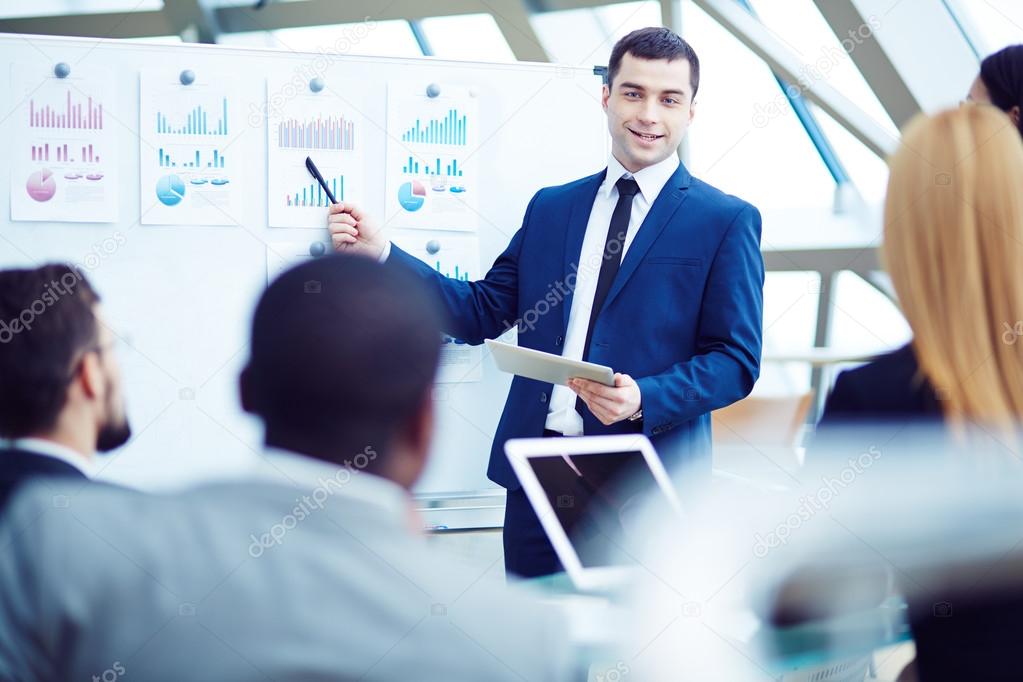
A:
[[139, 71, 248, 225]]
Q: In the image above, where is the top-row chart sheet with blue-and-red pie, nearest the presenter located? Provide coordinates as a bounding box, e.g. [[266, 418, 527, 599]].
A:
[[386, 82, 480, 231]]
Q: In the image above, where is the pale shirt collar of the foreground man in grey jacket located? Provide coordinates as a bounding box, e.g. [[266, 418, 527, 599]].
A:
[[254, 448, 411, 521]]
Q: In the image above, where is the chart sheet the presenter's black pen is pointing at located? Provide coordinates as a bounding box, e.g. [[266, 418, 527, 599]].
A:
[[267, 78, 365, 227]]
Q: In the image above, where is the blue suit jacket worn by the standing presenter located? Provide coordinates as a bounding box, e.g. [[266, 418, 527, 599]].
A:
[[390, 164, 764, 490]]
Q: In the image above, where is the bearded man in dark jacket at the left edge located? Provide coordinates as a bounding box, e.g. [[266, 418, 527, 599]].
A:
[[0, 265, 131, 507]]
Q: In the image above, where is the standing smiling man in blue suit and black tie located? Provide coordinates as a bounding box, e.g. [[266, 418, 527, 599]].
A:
[[328, 28, 764, 577]]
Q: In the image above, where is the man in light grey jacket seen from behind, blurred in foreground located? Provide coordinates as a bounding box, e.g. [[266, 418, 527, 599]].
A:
[[0, 256, 569, 682]]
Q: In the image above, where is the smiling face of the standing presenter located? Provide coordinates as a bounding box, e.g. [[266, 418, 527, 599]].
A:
[[603, 53, 694, 173]]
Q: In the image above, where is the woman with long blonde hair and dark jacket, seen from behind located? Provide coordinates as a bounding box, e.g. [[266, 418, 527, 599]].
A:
[[816, 104, 1023, 682]]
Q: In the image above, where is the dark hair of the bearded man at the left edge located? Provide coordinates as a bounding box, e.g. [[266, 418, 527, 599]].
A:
[[0, 264, 99, 439]]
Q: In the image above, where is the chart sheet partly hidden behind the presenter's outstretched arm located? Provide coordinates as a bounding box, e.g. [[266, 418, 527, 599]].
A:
[[391, 230, 483, 383]]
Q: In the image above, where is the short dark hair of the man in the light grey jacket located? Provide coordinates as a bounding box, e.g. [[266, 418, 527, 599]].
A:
[[242, 255, 441, 470]]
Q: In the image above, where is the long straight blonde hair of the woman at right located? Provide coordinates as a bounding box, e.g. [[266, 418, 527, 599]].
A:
[[882, 105, 1023, 428]]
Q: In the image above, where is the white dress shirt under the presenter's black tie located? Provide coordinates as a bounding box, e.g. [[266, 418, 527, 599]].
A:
[[546, 154, 678, 436]]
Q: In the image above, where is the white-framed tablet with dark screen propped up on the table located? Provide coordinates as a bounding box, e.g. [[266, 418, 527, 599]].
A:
[[504, 434, 681, 590]]
